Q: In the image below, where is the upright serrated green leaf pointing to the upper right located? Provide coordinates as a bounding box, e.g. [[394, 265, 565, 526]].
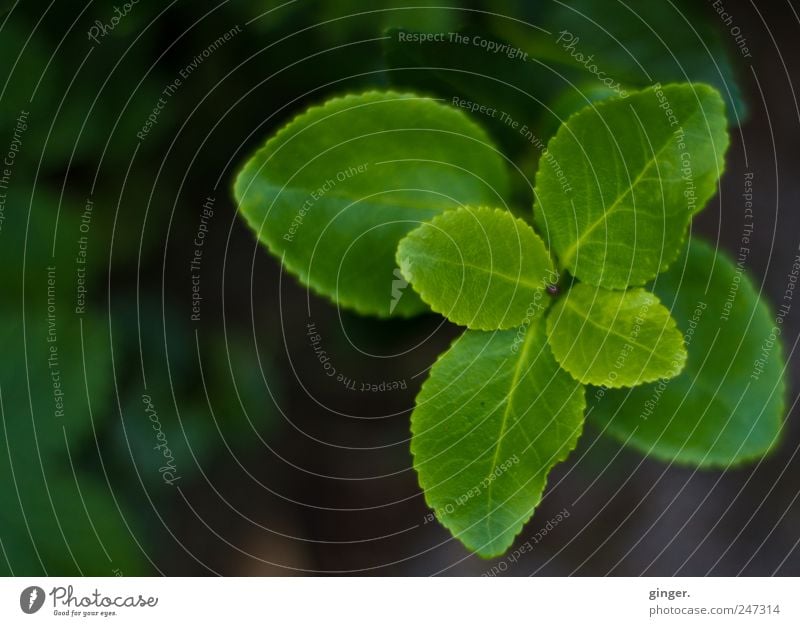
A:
[[534, 84, 728, 289]]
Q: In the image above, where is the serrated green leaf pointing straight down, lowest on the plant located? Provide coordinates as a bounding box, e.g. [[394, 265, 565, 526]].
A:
[[411, 321, 585, 557]]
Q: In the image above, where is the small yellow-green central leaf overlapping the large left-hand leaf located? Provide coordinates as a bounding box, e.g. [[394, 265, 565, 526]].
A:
[[397, 208, 558, 330]]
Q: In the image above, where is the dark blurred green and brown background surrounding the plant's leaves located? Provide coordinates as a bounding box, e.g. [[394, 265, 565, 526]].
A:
[[0, 0, 800, 575]]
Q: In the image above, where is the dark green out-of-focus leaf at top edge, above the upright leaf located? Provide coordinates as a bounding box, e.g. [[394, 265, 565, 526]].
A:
[[493, 0, 747, 125]]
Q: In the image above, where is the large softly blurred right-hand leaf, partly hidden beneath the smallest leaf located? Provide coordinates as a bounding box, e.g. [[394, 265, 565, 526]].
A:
[[590, 239, 786, 466]]
